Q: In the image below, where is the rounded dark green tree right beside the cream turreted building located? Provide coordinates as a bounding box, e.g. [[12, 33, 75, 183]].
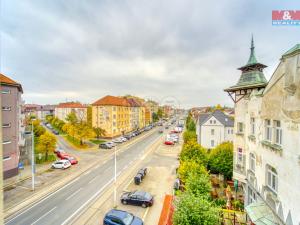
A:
[[209, 142, 233, 179]]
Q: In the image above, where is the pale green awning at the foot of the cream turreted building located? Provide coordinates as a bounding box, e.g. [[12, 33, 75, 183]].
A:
[[245, 201, 281, 225]]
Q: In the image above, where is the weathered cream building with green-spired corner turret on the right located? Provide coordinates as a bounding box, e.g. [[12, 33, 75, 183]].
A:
[[225, 39, 300, 225]]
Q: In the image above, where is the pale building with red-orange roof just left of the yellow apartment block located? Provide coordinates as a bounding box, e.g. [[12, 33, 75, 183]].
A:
[[54, 102, 87, 122]]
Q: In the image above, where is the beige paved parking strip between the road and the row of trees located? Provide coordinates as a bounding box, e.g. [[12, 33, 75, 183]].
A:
[[72, 126, 182, 225]]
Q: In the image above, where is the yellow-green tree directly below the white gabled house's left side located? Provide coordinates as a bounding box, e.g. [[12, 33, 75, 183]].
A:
[[180, 140, 208, 167]]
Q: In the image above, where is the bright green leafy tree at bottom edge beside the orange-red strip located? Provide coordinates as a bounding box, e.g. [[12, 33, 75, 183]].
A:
[[172, 193, 219, 225]]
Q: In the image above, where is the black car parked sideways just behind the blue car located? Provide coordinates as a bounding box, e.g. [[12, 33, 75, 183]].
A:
[[121, 191, 153, 208]]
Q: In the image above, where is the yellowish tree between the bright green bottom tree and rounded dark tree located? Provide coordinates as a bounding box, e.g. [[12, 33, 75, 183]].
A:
[[178, 161, 208, 183]]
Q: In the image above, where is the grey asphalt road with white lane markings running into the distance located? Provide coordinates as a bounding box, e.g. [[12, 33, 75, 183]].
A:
[[5, 132, 160, 225]]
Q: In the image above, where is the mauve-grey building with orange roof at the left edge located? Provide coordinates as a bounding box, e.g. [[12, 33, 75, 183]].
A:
[[0, 74, 25, 179]]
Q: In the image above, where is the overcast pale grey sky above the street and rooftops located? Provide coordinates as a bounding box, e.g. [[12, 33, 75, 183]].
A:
[[0, 0, 300, 108]]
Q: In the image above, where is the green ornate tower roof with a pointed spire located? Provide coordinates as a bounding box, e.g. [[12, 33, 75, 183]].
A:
[[225, 36, 267, 92]]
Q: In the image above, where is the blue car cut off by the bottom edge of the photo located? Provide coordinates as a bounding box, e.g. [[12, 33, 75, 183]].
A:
[[103, 209, 144, 225]]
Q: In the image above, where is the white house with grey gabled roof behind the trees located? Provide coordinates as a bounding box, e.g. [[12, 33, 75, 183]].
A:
[[196, 110, 234, 149]]
